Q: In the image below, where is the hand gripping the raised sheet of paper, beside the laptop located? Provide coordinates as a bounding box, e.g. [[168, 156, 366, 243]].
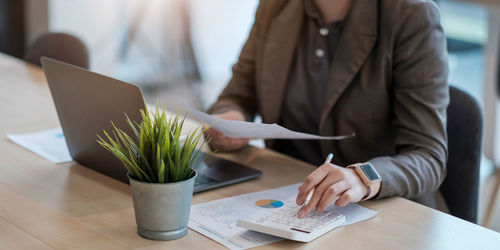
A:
[[205, 110, 249, 152]]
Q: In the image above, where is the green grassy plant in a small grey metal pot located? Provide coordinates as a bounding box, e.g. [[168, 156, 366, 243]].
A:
[[97, 105, 207, 240]]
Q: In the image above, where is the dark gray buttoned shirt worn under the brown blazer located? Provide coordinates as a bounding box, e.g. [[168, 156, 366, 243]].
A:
[[273, 0, 342, 166]]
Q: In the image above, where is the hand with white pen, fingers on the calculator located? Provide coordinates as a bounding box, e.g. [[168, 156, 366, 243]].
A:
[[296, 163, 368, 218]]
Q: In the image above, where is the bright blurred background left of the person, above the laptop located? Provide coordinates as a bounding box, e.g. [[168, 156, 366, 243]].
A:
[[0, 0, 258, 108]]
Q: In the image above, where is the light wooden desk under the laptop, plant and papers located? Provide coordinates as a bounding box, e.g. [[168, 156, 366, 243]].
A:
[[0, 54, 500, 249]]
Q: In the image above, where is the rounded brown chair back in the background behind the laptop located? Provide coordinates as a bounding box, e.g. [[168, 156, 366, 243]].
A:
[[24, 33, 89, 69]]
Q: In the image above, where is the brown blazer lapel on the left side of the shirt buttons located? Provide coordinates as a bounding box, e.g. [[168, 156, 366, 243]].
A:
[[258, 0, 304, 123]]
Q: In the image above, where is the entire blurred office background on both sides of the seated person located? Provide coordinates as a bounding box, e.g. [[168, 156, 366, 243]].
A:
[[0, 0, 500, 231]]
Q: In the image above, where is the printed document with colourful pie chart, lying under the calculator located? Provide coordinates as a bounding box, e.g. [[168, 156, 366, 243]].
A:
[[188, 183, 377, 249]]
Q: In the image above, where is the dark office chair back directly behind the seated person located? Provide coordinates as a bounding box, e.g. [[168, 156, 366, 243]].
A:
[[439, 87, 483, 223]]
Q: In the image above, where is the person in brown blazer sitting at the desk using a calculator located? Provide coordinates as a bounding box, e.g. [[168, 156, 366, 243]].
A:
[[207, 0, 448, 217]]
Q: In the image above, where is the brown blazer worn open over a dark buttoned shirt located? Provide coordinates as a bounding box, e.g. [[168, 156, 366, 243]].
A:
[[210, 0, 449, 208]]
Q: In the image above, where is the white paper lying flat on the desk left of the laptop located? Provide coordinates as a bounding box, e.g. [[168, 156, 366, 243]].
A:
[[7, 128, 73, 163]]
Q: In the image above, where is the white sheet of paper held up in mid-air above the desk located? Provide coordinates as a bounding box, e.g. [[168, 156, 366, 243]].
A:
[[181, 105, 356, 140]]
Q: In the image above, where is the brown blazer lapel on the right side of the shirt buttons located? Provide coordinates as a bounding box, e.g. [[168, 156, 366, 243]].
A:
[[319, 0, 378, 133]]
